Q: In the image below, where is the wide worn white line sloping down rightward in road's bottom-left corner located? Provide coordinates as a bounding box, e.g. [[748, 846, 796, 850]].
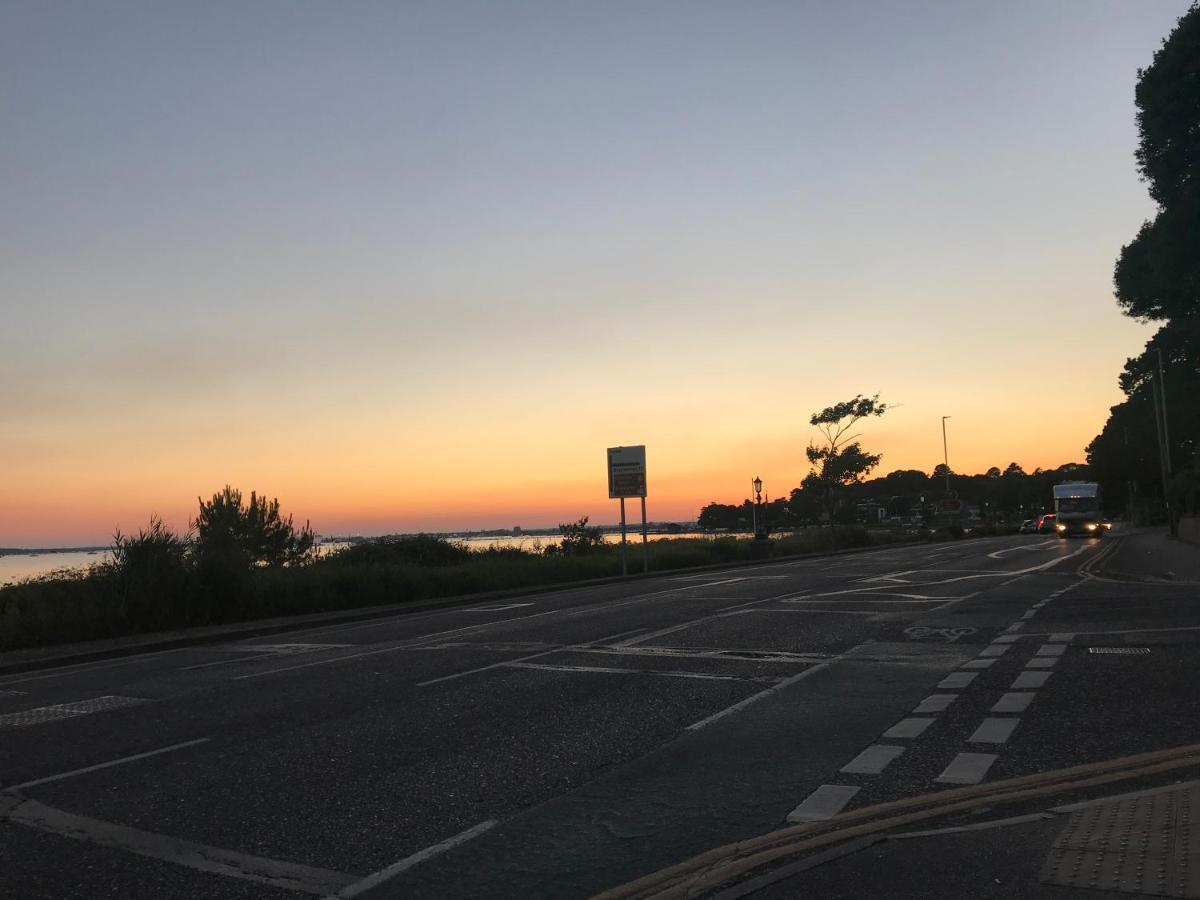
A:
[[7, 800, 354, 896]]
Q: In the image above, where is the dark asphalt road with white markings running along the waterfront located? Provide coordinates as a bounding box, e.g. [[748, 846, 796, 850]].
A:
[[0, 535, 1200, 900]]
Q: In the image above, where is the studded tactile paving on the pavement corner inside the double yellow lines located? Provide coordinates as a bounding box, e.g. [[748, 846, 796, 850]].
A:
[[1042, 787, 1200, 898]]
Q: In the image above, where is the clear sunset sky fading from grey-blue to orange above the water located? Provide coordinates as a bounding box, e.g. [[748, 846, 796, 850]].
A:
[[0, 0, 1188, 546]]
